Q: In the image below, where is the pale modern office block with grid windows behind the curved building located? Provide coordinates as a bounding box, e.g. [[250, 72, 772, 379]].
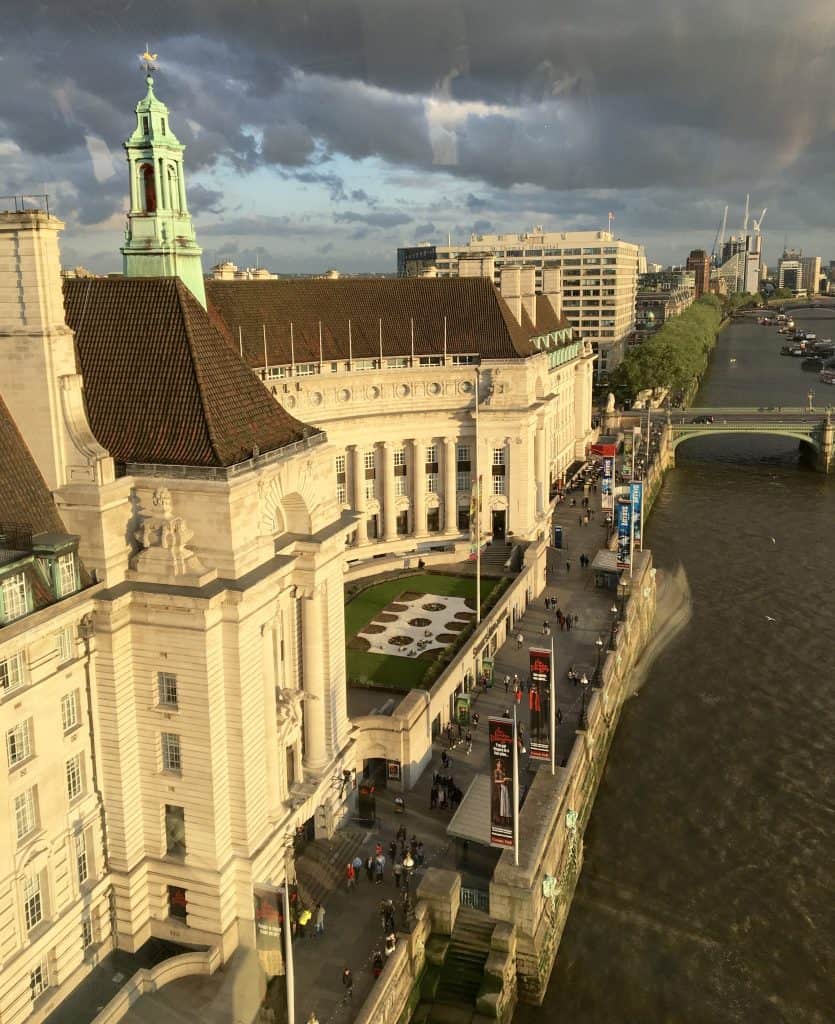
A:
[[398, 226, 645, 376]]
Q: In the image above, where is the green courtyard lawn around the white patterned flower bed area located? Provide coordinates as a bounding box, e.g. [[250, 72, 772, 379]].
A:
[[345, 573, 499, 692]]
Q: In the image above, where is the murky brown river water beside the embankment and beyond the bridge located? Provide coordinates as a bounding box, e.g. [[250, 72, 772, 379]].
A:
[[515, 310, 835, 1024]]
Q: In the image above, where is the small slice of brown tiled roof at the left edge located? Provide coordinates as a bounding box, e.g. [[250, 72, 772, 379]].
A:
[[0, 398, 67, 535]]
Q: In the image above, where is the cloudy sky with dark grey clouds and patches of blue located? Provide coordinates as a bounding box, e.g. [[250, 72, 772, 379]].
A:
[[0, 0, 835, 273]]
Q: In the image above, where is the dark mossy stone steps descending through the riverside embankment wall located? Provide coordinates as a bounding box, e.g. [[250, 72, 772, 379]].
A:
[[430, 906, 495, 1024]]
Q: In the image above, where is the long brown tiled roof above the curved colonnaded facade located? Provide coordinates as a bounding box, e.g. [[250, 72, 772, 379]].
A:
[[206, 278, 555, 368]]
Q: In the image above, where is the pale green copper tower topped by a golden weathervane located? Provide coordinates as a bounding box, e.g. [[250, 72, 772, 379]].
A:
[[122, 60, 206, 306]]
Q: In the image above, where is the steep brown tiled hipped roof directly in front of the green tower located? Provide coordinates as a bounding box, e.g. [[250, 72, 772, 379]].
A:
[[64, 278, 310, 466]]
